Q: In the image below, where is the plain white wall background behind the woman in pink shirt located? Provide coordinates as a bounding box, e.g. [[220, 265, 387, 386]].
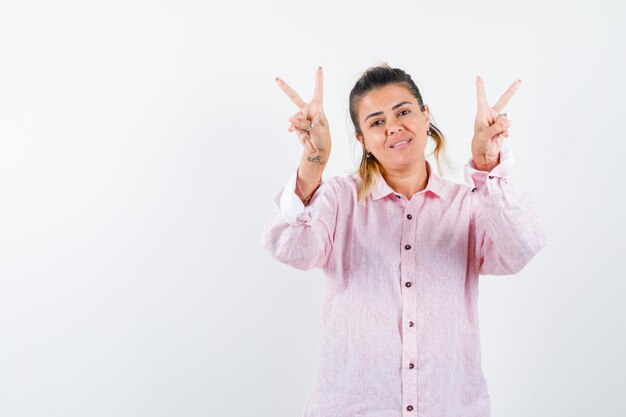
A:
[[0, 0, 626, 417]]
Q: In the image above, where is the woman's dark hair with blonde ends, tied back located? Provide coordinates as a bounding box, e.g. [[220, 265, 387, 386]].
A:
[[349, 62, 447, 202]]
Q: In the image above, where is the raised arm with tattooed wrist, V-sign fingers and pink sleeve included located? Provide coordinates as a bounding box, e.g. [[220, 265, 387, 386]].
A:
[[261, 67, 338, 270]]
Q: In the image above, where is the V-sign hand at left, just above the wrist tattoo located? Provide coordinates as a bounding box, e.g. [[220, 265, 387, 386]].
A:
[[276, 67, 331, 153]]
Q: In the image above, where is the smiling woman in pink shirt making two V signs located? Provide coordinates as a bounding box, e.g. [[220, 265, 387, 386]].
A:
[[262, 65, 545, 417]]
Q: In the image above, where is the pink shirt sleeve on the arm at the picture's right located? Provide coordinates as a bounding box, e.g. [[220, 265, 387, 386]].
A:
[[465, 140, 546, 275]]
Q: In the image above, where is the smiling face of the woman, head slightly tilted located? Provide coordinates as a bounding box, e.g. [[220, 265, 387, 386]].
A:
[[356, 84, 430, 170]]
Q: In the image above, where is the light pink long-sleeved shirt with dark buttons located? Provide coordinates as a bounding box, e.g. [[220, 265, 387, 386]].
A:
[[261, 144, 545, 417]]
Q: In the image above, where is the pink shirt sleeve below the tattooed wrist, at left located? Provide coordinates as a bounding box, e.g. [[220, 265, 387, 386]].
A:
[[261, 170, 337, 271]]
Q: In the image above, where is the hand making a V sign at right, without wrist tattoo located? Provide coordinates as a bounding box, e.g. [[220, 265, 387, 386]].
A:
[[472, 76, 522, 171]]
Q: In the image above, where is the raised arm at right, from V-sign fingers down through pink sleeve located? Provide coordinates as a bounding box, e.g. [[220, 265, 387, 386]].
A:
[[465, 77, 546, 275]]
